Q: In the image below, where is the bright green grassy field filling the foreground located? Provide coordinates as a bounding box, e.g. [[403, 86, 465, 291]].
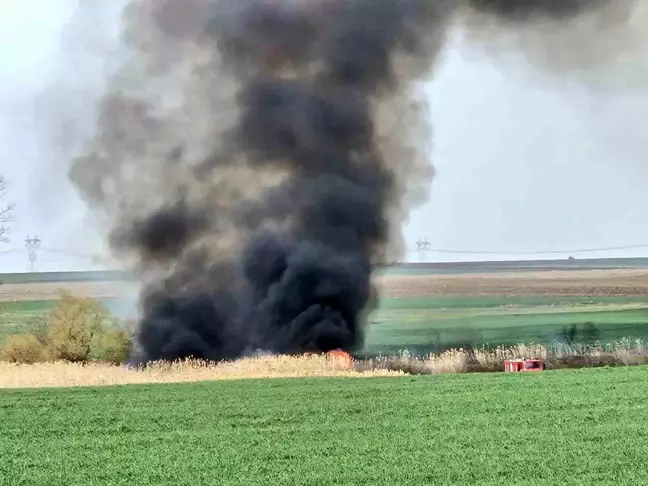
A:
[[0, 367, 648, 486]]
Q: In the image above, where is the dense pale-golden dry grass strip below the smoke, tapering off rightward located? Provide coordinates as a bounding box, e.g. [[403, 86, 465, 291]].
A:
[[0, 355, 404, 388]]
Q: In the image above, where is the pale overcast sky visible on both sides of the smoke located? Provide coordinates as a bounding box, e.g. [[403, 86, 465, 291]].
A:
[[0, 0, 648, 273]]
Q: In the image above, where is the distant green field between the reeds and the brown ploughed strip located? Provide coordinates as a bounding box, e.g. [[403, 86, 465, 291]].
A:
[[0, 296, 648, 354]]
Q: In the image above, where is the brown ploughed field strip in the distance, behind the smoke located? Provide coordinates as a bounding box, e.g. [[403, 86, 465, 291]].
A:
[[0, 269, 648, 301]]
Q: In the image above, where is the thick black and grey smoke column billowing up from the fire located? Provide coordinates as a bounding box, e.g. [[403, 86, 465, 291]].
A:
[[71, 0, 636, 360]]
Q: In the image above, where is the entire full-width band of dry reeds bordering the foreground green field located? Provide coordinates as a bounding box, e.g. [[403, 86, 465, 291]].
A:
[[0, 339, 648, 388]]
